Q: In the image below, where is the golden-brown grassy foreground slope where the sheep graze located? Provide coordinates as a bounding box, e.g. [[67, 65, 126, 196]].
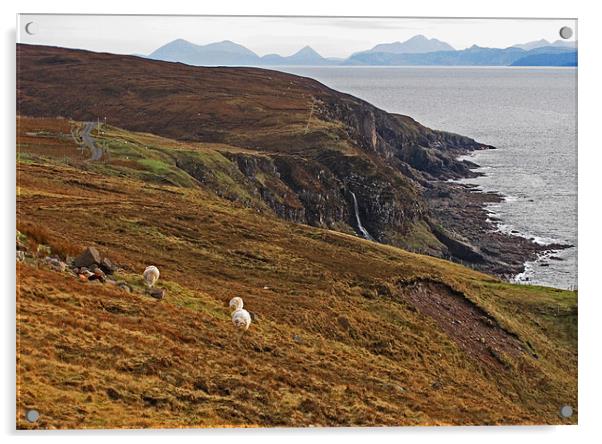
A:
[[17, 118, 577, 428]]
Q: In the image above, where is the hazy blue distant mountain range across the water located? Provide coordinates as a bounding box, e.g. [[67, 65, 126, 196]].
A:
[[146, 35, 577, 66]]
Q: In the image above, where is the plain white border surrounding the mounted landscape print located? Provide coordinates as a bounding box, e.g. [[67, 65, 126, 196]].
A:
[[0, 0, 602, 444]]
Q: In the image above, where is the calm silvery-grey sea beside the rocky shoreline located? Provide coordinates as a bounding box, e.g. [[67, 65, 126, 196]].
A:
[[278, 67, 577, 288]]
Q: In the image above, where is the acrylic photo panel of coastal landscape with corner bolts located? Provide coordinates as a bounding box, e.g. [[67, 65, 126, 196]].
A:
[[16, 14, 577, 429]]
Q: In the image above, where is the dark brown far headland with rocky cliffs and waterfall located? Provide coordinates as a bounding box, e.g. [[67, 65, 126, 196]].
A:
[[17, 45, 539, 275]]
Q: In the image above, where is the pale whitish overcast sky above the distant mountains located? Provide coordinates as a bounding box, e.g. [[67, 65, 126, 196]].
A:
[[17, 14, 576, 57]]
